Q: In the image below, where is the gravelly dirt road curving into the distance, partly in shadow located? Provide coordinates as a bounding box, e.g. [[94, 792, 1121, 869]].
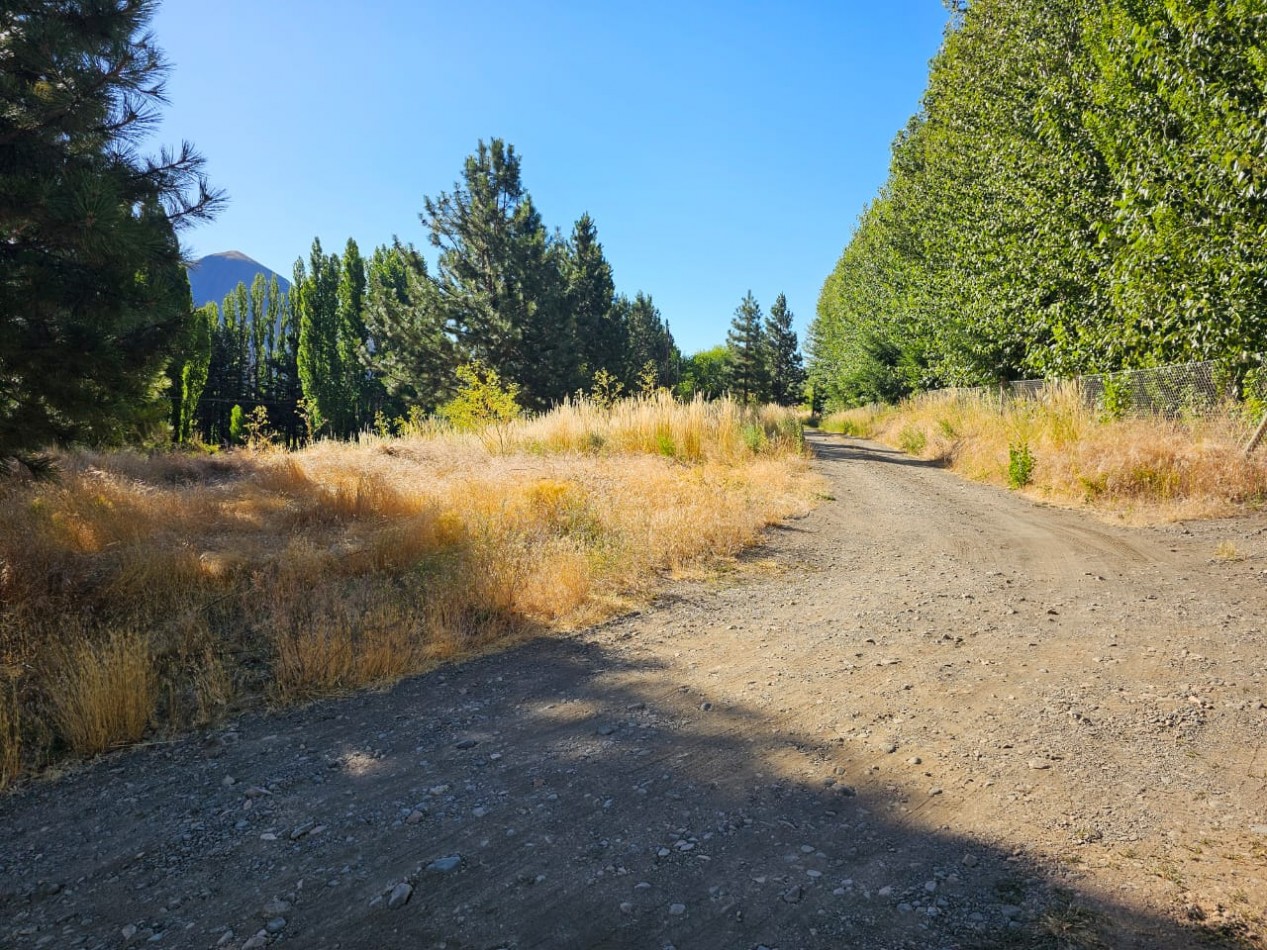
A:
[[0, 437, 1267, 950]]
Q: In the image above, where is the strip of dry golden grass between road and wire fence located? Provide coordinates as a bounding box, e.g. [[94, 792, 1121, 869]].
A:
[[824, 385, 1267, 523]]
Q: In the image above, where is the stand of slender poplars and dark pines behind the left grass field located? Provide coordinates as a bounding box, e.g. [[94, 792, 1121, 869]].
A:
[[179, 139, 682, 441]]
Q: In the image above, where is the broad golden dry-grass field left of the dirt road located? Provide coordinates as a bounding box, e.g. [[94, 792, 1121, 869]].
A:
[[0, 398, 812, 785]]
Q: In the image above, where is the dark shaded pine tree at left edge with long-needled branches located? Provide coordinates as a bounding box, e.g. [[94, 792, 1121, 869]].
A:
[[0, 0, 218, 461]]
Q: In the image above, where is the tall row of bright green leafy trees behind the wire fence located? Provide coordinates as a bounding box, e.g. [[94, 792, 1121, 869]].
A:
[[808, 0, 1267, 404]]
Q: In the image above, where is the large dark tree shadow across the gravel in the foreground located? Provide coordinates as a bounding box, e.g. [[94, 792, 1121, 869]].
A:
[[0, 628, 1234, 950]]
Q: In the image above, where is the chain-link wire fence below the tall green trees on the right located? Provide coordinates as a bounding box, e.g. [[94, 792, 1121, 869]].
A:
[[950, 360, 1243, 417]]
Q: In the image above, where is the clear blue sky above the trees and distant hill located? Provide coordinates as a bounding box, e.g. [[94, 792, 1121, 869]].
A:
[[153, 0, 946, 353]]
